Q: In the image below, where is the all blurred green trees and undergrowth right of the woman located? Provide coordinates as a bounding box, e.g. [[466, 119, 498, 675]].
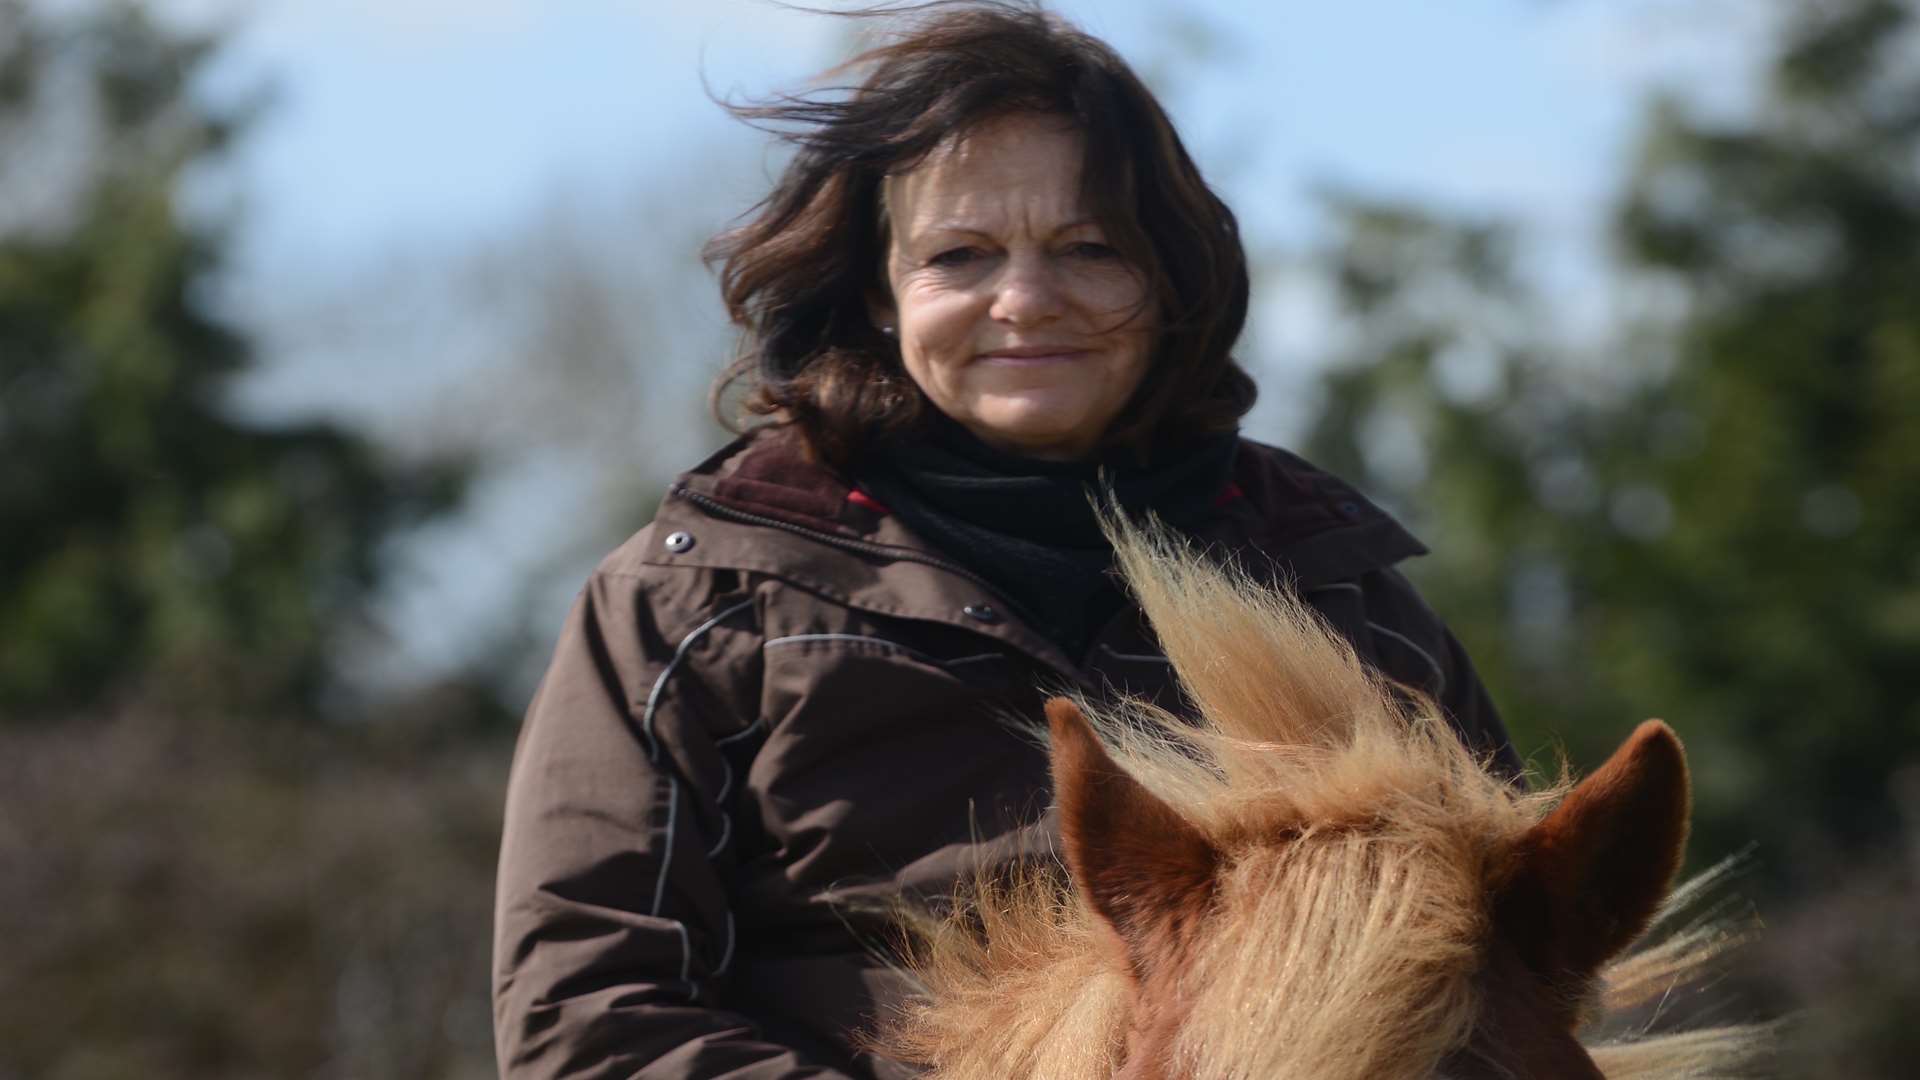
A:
[[1308, 0, 1920, 1076]]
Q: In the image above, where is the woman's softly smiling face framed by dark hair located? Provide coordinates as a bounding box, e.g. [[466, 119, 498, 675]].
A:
[[874, 115, 1154, 459]]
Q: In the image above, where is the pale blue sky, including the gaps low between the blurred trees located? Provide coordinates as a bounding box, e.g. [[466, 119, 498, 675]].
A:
[[142, 0, 1766, 684]]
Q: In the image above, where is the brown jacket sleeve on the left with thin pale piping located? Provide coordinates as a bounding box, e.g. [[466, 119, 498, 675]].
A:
[[493, 571, 860, 1080]]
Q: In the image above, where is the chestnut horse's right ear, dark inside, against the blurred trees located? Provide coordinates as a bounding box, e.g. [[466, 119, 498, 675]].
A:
[[1496, 721, 1692, 980]]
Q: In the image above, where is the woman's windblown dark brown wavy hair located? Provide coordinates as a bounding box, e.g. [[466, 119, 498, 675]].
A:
[[707, 0, 1254, 465]]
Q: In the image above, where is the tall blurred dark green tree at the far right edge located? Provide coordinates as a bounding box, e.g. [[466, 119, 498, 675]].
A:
[[1613, 0, 1920, 842]]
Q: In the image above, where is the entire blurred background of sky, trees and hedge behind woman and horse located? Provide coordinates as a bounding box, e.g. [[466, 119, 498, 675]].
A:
[[0, 0, 1920, 1078]]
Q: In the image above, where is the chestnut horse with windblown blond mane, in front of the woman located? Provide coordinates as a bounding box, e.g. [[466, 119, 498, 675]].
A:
[[874, 519, 1768, 1080]]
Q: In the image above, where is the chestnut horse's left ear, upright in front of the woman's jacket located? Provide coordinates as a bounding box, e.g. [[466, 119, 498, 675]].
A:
[[1046, 698, 1219, 974]]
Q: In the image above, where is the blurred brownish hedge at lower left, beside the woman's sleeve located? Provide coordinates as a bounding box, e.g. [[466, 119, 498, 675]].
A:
[[0, 694, 511, 1080]]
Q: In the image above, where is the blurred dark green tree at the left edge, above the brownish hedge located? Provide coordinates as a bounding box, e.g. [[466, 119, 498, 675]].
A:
[[0, 0, 461, 719]]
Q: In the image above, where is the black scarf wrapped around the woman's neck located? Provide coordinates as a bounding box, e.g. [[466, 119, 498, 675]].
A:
[[856, 417, 1238, 661]]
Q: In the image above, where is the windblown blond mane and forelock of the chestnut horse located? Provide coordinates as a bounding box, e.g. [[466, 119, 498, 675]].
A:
[[881, 525, 1764, 1080]]
